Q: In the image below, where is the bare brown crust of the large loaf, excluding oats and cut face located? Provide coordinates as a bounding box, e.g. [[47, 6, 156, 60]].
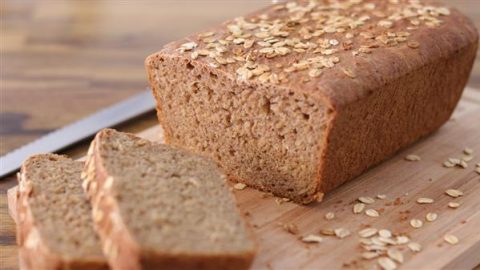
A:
[[145, 0, 478, 203]]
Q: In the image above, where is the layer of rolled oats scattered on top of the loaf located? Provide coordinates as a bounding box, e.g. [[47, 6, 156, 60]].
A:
[[178, 0, 450, 84]]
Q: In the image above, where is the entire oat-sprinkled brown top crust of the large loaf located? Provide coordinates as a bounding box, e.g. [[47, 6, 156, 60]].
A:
[[152, 0, 478, 107]]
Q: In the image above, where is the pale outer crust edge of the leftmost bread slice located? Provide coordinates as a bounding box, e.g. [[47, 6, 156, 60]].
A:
[[15, 154, 108, 270]]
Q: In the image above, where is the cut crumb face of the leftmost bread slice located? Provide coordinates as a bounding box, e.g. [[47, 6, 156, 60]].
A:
[[20, 154, 103, 261]]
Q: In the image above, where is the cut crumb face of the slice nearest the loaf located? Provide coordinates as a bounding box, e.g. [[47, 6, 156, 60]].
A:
[[97, 130, 254, 253]]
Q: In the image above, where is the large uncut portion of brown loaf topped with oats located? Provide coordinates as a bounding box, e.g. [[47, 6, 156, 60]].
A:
[[146, 0, 478, 203]]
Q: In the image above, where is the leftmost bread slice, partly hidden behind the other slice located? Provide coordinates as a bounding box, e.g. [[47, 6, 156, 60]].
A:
[[15, 154, 108, 269]]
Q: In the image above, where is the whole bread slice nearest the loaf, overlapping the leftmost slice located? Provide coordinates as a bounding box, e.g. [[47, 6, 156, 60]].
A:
[[84, 129, 255, 269]]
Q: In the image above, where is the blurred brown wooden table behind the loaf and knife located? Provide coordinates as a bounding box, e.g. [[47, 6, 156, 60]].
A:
[[0, 0, 480, 269]]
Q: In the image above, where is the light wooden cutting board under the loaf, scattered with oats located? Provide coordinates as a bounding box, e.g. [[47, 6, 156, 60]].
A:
[[3, 91, 480, 269]]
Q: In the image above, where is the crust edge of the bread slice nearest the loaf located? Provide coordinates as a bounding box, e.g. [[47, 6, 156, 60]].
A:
[[83, 129, 255, 270]]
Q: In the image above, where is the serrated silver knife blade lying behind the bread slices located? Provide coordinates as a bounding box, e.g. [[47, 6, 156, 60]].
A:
[[0, 90, 155, 177]]
